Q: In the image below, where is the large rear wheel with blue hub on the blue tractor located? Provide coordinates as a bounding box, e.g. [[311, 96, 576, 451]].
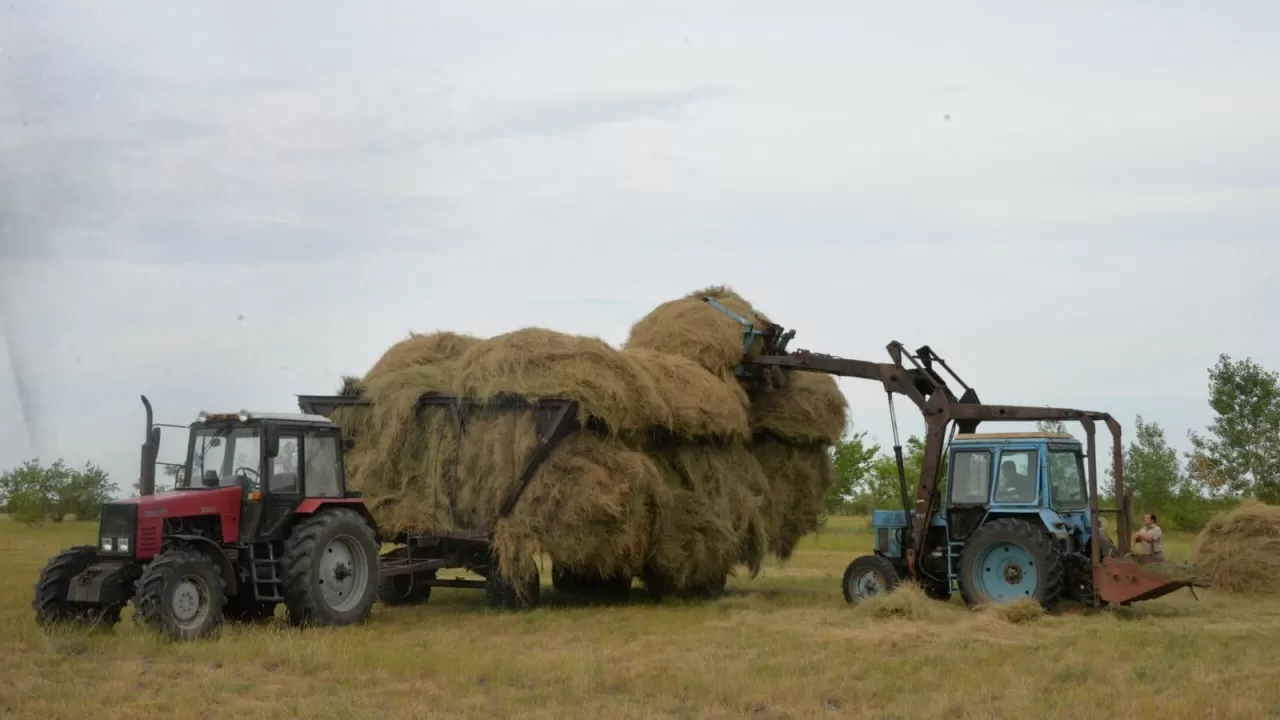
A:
[[960, 518, 1064, 610]]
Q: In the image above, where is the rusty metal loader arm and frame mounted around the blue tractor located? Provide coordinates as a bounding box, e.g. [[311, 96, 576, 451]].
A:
[[745, 338, 1193, 605]]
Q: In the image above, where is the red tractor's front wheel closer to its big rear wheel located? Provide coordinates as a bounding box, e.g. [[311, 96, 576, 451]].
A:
[[133, 548, 227, 641]]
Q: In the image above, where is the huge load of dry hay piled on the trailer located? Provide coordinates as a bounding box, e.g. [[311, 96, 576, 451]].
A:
[[334, 288, 846, 594]]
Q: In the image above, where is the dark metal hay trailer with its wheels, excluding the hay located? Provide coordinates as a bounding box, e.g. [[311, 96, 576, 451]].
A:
[[298, 393, 581, 610]]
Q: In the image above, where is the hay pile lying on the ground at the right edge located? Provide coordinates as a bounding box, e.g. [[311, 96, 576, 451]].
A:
[[1189, 501, 1280, 594]]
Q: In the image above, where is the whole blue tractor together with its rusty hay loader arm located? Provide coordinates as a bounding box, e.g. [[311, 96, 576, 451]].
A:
[[740, 319, 1203, 607]]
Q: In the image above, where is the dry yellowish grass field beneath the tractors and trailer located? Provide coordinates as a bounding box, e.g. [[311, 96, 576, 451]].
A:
[[0, 518, 1280, 720]]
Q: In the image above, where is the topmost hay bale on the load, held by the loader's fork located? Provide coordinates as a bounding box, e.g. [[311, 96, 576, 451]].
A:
[[623, 286, 769, 378]]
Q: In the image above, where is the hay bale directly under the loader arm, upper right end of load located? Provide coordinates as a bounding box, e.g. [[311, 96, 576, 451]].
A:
[[751, 370, 849, 443]]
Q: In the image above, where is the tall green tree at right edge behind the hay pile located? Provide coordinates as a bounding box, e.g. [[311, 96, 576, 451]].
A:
[[1189, 354, 1280, 502]]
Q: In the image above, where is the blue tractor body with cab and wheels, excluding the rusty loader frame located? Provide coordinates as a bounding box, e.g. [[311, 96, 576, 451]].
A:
[[844, 433, 1114, 609]]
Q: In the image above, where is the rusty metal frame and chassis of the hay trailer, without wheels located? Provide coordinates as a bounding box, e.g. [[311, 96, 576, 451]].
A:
[[298, 393, 581, 591]]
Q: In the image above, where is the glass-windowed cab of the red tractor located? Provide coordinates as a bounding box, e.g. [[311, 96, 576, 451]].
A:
[[174, 410, 348, 542]]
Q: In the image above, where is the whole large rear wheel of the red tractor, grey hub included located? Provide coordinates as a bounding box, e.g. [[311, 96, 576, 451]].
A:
[[283, 509, 378, 625]]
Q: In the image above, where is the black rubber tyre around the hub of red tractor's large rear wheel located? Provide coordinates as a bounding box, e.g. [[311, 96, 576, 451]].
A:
[[282, 509, 378, 626]]
